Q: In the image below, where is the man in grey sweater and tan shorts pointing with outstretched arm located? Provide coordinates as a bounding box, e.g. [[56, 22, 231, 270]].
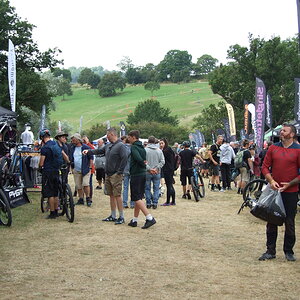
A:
[[83, 128, 128, 225]]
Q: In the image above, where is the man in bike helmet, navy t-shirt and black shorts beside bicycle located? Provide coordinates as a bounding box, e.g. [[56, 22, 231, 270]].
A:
[[39, 129, 59, 219]]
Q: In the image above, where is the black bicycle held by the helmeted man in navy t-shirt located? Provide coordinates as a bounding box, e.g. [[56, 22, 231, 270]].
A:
[[41, 166, 75, 223]]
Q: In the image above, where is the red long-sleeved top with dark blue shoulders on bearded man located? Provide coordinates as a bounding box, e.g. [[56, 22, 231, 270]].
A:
[[262, 142, 300, 193]]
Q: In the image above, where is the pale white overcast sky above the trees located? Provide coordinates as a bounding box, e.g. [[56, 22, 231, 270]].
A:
[[10, 0, 298, 70]]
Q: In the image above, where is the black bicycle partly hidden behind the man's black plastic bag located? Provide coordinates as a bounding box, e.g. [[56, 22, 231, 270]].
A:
[[238, 179, 268, 214]]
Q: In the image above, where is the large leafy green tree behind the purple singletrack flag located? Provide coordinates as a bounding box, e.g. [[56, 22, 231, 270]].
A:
[[209, 35, 300, 126]]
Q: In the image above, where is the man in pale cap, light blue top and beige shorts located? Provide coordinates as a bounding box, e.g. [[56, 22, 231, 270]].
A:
[[70, 133, 93, 206]]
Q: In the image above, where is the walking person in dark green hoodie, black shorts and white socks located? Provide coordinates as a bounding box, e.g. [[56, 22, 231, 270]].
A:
[[128, 130, 156, 229]]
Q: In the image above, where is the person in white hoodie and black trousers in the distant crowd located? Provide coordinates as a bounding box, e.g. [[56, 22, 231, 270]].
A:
[[220, 141, 235, 192]]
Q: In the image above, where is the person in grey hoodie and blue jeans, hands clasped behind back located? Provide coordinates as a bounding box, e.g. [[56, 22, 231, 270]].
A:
[[145, 136, 165, 209]]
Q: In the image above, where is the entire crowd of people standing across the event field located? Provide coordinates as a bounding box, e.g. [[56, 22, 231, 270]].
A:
[[40, 124, 300, 261]]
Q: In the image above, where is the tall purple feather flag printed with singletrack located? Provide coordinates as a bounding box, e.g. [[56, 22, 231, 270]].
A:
[[255, 78, 266, 153]]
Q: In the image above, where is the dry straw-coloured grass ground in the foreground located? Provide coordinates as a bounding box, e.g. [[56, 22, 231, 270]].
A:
[[0, 177, 300, 300]]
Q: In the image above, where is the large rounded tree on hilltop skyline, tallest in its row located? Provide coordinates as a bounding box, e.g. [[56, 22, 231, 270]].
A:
[[157, 50, 192, 81]]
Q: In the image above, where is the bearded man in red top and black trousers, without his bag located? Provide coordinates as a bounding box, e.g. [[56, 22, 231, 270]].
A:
[[259, 124, 300, 261]]
